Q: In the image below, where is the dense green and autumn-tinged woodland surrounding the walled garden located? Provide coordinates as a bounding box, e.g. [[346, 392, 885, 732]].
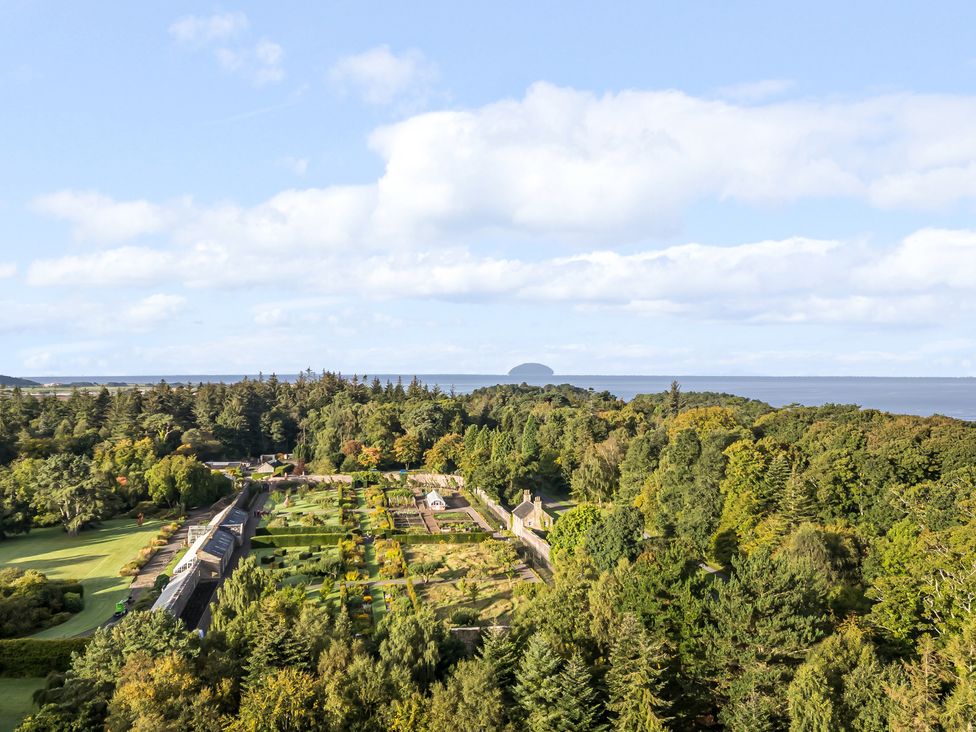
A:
[[0, 373, 976, 732]]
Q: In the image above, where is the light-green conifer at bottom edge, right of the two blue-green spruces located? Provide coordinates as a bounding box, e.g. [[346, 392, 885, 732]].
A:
[[607, 613, 666, 732]]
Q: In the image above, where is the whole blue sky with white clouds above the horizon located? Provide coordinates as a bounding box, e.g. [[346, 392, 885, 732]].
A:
[[0, 0, 976, 376]]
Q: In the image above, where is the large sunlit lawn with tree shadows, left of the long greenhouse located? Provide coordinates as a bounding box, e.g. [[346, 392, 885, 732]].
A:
[[0, 519, 163, 638]]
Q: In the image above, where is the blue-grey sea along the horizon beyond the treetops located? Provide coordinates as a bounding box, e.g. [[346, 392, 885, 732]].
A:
[[29, 374, 976, 421]]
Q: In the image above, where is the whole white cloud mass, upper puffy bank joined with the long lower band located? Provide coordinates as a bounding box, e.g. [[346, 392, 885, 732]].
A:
[[27, 84, 976, 334]]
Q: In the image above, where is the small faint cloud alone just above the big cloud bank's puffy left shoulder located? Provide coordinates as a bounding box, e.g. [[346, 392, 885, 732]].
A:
[[329, 45, 438, 106]]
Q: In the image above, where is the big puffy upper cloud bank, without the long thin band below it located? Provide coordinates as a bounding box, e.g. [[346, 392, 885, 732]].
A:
[[30, 84, 976, 251]]
